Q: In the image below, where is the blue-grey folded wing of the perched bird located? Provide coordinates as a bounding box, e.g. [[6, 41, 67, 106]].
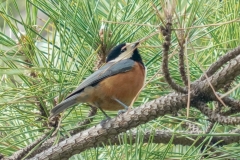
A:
[[66, 59, 134, 99]]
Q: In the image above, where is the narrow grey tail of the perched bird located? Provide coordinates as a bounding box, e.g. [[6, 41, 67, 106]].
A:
[[50, 94, 79, 117]]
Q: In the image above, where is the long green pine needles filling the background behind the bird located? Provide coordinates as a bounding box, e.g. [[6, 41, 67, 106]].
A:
[[0, 0, 240, 160]]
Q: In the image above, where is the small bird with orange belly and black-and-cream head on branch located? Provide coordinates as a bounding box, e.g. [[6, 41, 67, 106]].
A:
[[50, 41, 146, 119]]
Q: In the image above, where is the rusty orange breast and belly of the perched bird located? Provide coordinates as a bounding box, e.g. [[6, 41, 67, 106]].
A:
[[89, 62, 145, 111]]
